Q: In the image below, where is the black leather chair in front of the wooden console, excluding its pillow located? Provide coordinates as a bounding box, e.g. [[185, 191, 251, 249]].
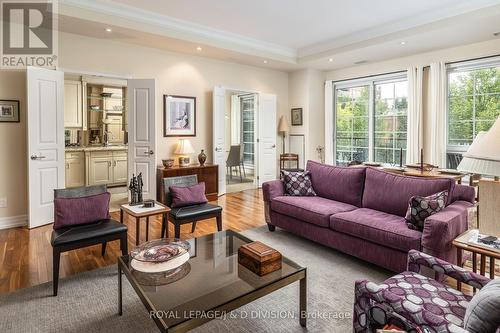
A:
[[161, 175, 222, 238]]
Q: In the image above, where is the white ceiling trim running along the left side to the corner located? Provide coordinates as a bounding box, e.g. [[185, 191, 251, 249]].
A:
[[59, 0, 297, 63]]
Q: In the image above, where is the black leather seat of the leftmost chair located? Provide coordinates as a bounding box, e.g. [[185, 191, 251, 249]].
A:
[[51, 219, 127, 246]]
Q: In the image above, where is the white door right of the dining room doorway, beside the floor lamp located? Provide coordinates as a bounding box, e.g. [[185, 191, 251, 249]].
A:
[[257, 94, 278, 187]]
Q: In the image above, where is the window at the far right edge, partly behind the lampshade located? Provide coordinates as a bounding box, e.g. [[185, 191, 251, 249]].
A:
[[447, 58, 500, 168]]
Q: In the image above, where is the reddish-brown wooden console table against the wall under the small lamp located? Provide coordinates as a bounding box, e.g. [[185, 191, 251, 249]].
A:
[[156, 164, 219, 202]]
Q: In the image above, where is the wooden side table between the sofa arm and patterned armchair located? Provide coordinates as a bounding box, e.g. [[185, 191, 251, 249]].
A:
[[452, 229, 500, 290]]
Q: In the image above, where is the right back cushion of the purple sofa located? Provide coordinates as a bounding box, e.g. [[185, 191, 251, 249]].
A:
[[362, 168, 455, 216]]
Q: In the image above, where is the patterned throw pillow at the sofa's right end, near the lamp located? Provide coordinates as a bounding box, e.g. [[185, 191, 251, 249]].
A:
[[405, 191, 448, 231]]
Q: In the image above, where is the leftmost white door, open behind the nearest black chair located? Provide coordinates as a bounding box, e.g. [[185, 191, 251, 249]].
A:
[[26, 67, 65, 228]]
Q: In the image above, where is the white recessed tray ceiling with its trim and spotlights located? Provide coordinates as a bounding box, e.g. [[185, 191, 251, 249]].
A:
[[59, 0, 500, 71]]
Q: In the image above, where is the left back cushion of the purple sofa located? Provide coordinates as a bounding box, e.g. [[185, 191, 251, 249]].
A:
[[307, 161, 366, 207]]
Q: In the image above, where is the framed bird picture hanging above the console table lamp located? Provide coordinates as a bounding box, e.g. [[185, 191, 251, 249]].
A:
[[163, 95, 196, 137]]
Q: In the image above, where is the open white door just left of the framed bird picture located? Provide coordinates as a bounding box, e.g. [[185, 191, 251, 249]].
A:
[[127, 79, 156, 199]]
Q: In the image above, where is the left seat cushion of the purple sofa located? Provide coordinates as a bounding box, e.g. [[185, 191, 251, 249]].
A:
[[271, 196, 357, 228]]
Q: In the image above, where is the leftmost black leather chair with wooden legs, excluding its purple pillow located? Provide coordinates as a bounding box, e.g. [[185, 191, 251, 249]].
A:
[[50, 185, 128, 296]]
